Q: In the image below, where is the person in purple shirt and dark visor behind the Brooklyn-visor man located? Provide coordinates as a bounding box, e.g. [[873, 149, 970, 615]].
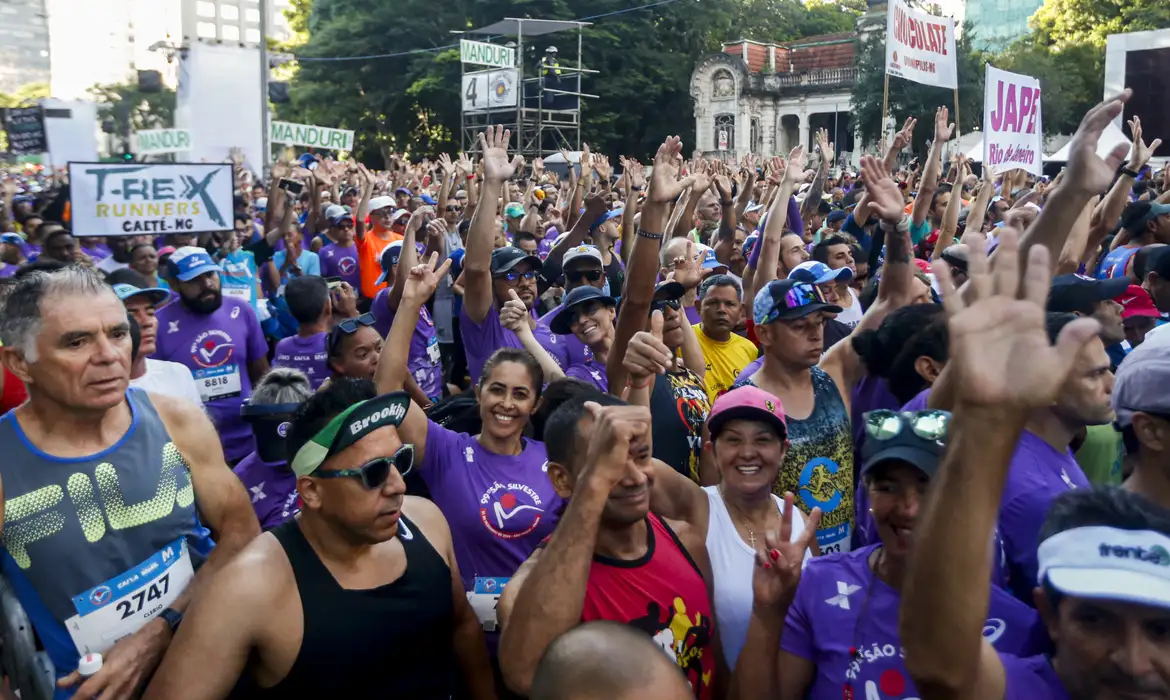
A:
[[232, 368, 312, 530]]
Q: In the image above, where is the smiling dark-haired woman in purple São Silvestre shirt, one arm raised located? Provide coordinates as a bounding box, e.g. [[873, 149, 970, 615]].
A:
[[376, 255, 564, 652]]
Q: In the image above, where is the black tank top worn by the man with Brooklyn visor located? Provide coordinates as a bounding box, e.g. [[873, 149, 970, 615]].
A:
[[233, 515, 459, 700]]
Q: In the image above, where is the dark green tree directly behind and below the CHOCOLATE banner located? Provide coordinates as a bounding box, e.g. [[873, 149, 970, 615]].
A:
[[852, 25, 987, 156]]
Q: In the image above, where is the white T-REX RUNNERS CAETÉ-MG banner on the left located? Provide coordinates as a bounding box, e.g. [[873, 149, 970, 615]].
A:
[[69, 163, 233, 235]]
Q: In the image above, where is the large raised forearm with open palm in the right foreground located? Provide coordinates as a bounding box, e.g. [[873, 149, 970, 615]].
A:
[[901, 231, 1099, 700]]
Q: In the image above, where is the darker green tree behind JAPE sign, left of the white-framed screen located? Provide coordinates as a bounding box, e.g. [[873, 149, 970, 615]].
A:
[[989, 36, 1104, 136]]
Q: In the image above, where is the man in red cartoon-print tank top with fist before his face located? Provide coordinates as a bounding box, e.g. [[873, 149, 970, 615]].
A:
[[497, 393, 729, 700]]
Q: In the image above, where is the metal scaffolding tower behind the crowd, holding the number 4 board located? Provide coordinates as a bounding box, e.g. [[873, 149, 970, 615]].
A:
[[453, 18, 598, 159]]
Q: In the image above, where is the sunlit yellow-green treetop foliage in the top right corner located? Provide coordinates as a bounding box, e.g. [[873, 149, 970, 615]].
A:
[[1028, 0, 1170, 48]]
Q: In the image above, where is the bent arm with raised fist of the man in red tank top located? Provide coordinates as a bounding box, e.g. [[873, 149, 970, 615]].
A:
[[500, 403, 651, 695]]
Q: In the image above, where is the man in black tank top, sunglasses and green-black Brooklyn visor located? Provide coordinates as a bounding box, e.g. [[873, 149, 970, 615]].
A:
[[144, 378, 495, 700]]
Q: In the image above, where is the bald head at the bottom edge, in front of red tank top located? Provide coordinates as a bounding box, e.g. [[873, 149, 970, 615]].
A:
[[528, 622, 694, 700]]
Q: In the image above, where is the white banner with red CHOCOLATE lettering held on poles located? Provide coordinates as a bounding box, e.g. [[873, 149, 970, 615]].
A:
[[886, 0, 958, 88]]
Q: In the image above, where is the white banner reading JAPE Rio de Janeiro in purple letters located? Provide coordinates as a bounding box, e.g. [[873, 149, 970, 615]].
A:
[[983, 63, 1044, 176]]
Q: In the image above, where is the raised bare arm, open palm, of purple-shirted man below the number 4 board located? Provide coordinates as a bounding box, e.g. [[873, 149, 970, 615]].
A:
[[463, 126, 521, 323]]
